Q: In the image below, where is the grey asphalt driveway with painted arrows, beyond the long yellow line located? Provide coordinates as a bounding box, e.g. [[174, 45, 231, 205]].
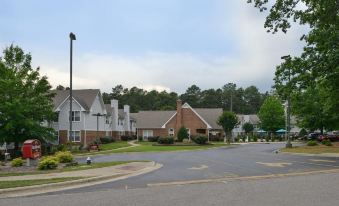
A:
[[52, 143, 339, 194]]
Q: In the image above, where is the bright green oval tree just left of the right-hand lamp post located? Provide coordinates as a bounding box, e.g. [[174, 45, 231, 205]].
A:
[[258, 96, 285, 134]]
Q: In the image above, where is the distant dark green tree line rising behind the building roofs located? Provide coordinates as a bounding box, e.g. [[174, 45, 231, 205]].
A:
[[102, 83, 268, 114]]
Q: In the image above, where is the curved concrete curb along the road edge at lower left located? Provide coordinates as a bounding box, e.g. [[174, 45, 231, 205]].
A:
[[0, 162, 163, 198]]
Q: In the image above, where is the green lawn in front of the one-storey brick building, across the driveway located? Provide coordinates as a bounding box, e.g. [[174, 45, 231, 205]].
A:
[[110, 142, 226, 153]]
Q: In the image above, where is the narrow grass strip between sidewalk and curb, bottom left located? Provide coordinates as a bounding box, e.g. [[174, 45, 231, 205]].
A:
[[0, 177, 82, 189]]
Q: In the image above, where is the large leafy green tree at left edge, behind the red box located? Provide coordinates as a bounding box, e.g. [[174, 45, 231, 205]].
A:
[[0, 45, 55, 148]]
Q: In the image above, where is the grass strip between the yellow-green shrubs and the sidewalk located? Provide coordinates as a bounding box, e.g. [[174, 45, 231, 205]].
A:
[[0, 161, 140, 177]]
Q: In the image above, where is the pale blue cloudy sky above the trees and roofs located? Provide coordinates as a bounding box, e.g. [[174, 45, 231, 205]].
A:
[[0, 0, 305, 94]]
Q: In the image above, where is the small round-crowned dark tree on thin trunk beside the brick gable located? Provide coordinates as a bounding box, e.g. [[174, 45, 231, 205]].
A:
[[217, 111, 238, 143]]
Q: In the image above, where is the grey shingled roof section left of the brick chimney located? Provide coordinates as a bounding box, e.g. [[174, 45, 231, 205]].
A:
[[133, 111, 176, 128]]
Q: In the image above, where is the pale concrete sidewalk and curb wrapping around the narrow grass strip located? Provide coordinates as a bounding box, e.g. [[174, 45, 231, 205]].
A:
[[0, 162, 162, 198]]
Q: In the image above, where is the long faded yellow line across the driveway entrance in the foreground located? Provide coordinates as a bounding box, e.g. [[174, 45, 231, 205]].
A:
[[147, 169, 339, 187]]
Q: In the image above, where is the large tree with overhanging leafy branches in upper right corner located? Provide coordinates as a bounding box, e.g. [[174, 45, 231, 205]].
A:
[[248, 0, 339, 128]]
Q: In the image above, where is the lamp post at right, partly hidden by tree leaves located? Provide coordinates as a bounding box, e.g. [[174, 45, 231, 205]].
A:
[[281, 55, 292, 148]]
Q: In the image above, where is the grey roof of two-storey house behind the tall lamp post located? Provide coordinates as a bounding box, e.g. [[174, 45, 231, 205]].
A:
[[52, 89, 100, 110]]
